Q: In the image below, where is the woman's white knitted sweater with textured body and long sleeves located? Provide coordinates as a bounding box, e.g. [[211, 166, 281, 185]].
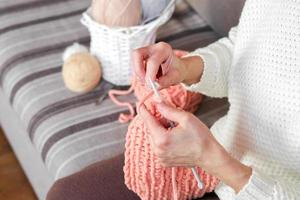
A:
[[187, 0, 300, 200]]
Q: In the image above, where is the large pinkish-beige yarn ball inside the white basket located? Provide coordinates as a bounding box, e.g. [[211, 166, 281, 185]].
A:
[[92, 0, 142, 27]]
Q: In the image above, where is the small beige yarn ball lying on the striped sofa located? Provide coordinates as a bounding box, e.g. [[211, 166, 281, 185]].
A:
[[62, 52, 101, 93]]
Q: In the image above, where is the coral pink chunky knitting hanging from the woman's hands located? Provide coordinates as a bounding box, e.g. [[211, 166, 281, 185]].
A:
[[123, 80, 218, 200]]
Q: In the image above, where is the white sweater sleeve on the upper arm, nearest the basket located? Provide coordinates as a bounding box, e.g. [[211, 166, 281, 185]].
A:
[[183, 27, 237, 97]]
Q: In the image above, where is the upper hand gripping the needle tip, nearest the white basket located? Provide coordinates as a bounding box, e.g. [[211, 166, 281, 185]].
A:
[[132, 42, 188, 88]]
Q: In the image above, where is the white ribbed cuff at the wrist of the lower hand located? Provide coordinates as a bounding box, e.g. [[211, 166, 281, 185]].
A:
[[235, 169, 276, 200]]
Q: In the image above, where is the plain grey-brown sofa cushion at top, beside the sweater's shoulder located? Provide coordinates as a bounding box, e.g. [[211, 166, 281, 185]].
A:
[[187, 0, 245, 36]]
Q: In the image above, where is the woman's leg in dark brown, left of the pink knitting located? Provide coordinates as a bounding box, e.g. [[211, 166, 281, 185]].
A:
[[47, 155, 139, 200]]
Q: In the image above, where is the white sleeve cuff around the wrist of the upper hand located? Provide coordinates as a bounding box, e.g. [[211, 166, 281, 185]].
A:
[[182, 50, 218, 95]]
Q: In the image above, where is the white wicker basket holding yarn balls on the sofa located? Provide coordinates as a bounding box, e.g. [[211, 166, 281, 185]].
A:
[[81, 0, 175, 85]]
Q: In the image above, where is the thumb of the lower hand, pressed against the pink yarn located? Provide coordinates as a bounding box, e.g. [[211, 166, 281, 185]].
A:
[[157, 103, 187, 124]]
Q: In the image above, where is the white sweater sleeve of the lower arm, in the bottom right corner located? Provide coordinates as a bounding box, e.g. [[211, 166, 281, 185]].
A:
[[235, 170, 300, 200]]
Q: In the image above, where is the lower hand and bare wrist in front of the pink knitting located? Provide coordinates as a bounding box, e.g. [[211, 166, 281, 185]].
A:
[[139, 103, 252, 192]]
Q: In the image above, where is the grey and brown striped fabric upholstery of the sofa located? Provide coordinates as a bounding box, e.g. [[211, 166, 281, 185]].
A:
[[0, 0, 228, 179]]
